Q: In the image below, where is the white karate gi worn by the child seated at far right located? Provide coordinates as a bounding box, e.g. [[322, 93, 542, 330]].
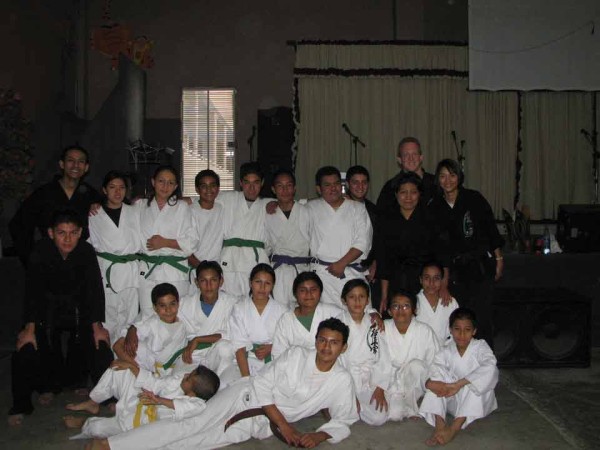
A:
[[419, 339, 498, 429]]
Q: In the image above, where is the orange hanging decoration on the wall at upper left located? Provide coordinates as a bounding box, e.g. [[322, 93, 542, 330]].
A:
[[91, 0, 154, 70]]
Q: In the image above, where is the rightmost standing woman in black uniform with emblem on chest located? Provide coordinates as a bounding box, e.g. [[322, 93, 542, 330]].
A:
[[428, 159, 504, 346]]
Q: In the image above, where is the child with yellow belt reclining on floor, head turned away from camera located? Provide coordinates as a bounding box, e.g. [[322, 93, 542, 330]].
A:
[[63, 360, 220, 439]]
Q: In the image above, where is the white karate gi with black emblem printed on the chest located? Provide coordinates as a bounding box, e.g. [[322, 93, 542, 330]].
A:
[[340, 311, 392, 425]]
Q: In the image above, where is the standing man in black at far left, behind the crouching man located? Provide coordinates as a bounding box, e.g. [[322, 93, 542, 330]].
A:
[[9, 146, 102, 265]]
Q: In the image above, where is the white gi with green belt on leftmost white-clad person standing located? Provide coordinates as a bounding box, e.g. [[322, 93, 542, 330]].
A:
[[88, 204, 143, 345]]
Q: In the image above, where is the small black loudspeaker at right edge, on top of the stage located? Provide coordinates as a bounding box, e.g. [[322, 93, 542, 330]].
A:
[[556, 205, 600, 253]]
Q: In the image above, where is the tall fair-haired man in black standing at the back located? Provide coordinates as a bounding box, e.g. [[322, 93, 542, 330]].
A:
[[377, 137, 436, 215]]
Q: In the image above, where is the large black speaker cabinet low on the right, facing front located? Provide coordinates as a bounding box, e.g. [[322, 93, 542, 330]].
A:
[[494, 288, 592, 367]]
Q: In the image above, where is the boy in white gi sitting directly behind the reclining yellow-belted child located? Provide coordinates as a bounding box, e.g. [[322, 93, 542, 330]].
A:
[[113, 283, 188, 376]]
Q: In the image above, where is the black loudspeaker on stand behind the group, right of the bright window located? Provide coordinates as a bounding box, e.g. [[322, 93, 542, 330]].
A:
[[257, 106, 294, 197]]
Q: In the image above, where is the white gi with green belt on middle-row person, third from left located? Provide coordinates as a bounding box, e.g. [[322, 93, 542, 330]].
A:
[[221, 296, 287, 385]]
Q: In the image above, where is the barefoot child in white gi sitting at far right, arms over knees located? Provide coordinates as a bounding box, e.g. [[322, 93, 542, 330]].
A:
[[419, 308, 498, 446]]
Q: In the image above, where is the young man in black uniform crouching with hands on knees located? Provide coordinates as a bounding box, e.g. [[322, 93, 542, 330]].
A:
[[9, 210, 112, 425]]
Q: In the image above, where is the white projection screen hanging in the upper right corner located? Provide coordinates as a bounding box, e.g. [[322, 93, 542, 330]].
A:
[[469, 0, 600, 91]]
